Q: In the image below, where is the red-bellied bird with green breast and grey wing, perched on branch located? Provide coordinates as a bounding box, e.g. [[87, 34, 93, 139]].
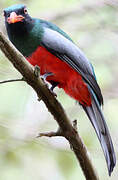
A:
[[3, 4, 116, 176]]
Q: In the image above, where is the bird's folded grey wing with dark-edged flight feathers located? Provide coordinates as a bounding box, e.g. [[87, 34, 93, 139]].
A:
[[41, 27, 103, 105]]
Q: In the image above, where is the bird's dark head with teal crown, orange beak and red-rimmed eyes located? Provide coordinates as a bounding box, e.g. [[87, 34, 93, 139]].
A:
[[4, 4, 32, 35]]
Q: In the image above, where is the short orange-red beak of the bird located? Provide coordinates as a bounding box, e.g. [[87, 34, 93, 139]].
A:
[[7, 12, 24, 24]]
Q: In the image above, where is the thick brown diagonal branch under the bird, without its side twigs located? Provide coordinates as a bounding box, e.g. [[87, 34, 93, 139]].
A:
[[0, 32, 98, 180]]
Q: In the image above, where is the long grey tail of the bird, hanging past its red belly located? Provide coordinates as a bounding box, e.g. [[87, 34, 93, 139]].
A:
[[82, 90, 116, 176]]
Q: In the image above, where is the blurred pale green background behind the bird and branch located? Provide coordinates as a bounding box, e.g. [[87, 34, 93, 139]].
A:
[[0, 0, 118, 180]]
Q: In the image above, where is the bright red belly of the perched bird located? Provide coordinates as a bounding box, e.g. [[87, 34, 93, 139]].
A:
[[27, 47, 91, 106]]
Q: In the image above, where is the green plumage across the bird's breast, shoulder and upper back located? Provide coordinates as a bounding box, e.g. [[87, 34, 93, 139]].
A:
[[10, 18, 72, 57]]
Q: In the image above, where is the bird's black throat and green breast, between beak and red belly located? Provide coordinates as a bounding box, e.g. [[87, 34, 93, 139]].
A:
[[7, 20, 43, 57]]
